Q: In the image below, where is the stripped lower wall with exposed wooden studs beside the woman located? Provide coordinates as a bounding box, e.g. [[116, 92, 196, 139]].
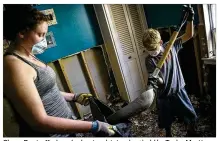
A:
[[49, 46, 110, 117]]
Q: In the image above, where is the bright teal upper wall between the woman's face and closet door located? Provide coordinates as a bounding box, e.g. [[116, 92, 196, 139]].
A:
[[36, 4, 103, 63]]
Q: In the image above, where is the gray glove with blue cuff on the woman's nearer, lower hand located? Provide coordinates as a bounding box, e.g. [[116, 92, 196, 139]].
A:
[[91, 120, 115, 137]]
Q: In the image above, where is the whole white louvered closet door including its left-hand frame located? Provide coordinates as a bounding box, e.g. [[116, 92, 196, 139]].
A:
[[94, 4, 147, 101]]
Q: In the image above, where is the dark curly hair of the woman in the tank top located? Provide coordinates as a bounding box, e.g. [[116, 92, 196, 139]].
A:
[[3, 4, 48, 41]]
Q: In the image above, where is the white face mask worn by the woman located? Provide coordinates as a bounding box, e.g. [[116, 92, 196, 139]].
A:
[[32, 38, 47, 54]]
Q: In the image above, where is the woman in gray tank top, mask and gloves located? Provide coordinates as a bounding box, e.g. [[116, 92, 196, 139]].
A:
[[3, 5, 115, 137]]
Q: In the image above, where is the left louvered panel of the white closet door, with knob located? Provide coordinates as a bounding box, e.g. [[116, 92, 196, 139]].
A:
[[108, 4, 145, 101]]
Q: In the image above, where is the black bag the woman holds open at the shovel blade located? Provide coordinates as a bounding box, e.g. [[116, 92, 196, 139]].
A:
[[89, 97, 132, 137]]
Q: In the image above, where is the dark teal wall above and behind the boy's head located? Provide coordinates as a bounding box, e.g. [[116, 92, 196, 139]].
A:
[[143, 4, 199, 28]]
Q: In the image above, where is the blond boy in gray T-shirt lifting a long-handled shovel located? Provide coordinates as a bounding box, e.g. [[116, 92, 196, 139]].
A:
[[143, 7, 197, 137]]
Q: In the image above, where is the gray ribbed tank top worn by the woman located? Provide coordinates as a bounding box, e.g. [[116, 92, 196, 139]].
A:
[[4, 53, 73, 137]]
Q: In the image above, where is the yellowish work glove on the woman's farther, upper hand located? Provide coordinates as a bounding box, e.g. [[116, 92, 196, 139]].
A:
[[73, 93, 92, 106]]
